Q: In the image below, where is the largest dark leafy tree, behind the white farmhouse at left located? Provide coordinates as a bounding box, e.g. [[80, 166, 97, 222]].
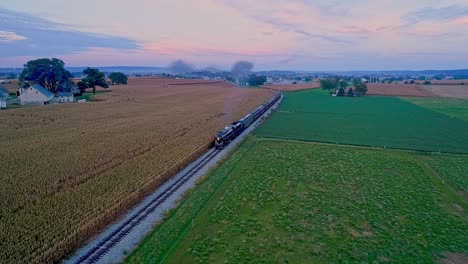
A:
[[19, 58, 73, 93]]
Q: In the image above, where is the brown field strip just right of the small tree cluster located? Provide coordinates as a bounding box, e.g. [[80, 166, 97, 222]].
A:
[[367, 83, 436, 97]]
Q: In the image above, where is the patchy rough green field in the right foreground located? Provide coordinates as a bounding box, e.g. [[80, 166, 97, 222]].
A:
[[126, 137, 468, 263]]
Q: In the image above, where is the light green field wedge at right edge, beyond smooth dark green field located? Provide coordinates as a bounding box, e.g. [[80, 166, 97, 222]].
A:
[[403, 97, 468, 121]]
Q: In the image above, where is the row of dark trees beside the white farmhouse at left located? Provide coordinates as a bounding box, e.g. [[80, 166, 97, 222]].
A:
[[19, 58, 128, 94]]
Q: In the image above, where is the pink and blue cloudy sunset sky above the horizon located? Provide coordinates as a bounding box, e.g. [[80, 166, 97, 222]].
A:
[[0, 0, 468, 71]]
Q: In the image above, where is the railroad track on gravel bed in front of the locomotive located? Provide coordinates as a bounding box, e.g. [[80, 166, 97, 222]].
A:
[[75, 149, 220, 264]]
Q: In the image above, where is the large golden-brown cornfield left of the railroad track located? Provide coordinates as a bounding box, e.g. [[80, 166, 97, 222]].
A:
[[0, 78, 273, 263]]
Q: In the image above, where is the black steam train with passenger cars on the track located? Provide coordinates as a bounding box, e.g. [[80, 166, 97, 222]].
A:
[[215, 92, 281, 149]]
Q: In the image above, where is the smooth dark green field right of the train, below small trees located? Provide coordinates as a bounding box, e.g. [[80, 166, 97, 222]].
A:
[[255, 90, 468, 153]]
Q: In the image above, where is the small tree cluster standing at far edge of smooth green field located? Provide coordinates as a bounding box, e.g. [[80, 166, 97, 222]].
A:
[[320, 78, 367, 96]]
